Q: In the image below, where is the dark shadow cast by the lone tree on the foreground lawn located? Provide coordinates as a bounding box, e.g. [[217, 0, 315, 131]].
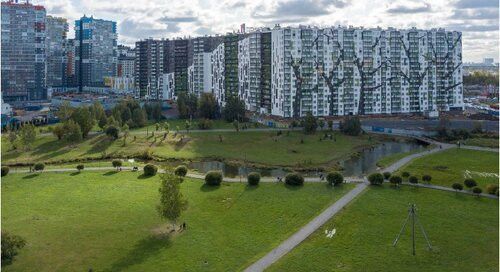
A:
[[106, 235, 172, 271]]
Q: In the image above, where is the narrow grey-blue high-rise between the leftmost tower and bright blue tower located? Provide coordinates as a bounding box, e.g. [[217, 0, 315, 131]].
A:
[[45, 16, 68, 87]]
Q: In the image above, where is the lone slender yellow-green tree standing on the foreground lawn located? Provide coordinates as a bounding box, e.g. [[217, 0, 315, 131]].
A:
[[156, 172, 188, 226]]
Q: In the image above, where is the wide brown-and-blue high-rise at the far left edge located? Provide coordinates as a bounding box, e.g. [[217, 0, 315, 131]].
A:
[[1, 1, 47, 102]]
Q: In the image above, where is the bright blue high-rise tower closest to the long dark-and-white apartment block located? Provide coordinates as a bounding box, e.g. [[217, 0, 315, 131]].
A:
[[75, 16, 117, 91]]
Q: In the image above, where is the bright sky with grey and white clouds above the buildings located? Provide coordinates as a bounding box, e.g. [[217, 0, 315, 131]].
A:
[[31, 0, 499, 62]]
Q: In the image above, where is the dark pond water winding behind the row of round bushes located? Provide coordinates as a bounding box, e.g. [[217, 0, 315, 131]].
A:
[[189, 142, 425, 177]]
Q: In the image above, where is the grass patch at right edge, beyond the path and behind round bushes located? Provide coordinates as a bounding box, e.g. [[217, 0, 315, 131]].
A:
[[399, 148, 498, 191]]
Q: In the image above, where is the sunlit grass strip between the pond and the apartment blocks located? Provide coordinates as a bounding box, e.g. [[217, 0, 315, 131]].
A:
[[2, 131, 383, 167]]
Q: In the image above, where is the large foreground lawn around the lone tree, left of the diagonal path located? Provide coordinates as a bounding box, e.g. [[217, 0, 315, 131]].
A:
[[2, 171, 352, 271]]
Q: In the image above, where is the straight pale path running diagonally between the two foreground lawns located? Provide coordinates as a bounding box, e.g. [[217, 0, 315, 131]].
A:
[[245, 182, 368, 272]]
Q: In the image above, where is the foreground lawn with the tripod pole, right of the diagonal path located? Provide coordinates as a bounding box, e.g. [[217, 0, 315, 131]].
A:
[[268, 186, 499, 272]]
